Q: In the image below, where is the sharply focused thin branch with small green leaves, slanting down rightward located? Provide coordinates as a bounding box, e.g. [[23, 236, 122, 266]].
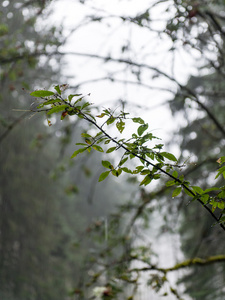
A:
[[31, 85, 225, 229]]
